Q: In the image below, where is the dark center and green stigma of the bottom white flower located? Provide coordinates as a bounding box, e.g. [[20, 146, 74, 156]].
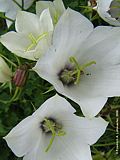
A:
[[43, 118, 66, 152]]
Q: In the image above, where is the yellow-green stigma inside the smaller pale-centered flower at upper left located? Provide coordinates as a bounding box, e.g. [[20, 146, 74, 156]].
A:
[[25, 32, 48, 52]]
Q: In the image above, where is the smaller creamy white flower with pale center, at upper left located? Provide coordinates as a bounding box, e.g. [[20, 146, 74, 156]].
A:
[[0, 9, 53, 60]]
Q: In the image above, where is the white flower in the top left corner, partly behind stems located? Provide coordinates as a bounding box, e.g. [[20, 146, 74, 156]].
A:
[[0, 0, 34, 27]]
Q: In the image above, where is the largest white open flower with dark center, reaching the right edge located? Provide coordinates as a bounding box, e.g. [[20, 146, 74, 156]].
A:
[[33, 9, 120, 117]]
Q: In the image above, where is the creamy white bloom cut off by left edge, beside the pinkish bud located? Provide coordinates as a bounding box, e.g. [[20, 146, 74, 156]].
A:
[[0, 57, 12, 83]]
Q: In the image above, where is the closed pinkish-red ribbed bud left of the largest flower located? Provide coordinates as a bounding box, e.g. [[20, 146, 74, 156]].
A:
[[12, 64, 29, 87]]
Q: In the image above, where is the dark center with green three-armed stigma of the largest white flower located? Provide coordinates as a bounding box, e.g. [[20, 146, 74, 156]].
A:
[[58, 57, 96, 86]]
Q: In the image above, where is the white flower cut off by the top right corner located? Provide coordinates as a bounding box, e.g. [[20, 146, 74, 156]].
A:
[[97, 0, 120, 26]]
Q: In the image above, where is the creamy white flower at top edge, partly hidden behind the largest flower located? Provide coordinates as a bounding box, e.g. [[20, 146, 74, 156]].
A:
[[36, 0, 65, 24]]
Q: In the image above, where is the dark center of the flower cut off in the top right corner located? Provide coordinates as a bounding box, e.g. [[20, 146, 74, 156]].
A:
[[108, 0, 120, 22]]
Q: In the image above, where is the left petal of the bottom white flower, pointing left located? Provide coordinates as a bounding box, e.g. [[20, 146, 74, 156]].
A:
[[4, 116, 41, 157]]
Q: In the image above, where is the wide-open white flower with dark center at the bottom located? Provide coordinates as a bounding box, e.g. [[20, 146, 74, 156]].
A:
[[4, 95, 108, 160]]
